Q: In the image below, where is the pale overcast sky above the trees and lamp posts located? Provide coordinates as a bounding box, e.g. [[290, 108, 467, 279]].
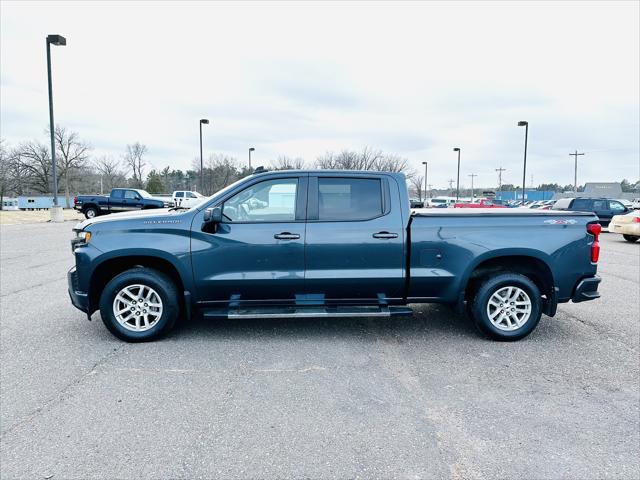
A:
[[0, 1, 640, 188]]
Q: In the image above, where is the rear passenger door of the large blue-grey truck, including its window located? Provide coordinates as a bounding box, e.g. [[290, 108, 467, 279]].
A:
[[305, 173, 404, 303]]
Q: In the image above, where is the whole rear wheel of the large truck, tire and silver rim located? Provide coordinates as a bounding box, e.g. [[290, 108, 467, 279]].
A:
[[469, 273, 542, 341]]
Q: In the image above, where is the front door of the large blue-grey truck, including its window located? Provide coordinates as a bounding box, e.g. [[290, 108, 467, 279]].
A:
[[191, 174, 307, 305]]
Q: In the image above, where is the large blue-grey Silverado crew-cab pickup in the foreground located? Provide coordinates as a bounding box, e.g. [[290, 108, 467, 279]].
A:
[[68, 170, 600, 342]]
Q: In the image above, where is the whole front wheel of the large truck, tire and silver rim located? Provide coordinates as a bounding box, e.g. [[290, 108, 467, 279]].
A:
[[100, 267, 180, 342]]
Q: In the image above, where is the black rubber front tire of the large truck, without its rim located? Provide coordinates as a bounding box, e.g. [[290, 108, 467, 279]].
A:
[[100, 267, 180, 342]]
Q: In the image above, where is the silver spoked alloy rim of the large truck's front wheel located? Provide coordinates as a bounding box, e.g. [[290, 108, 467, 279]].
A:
[[113, 285, 162, 332]]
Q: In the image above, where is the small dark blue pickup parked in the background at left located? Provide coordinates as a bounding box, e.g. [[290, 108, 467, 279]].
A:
[[73, 188, 169, 218]]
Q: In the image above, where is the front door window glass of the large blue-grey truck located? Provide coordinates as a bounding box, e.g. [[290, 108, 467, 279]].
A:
[[222, 178, 298, 222]]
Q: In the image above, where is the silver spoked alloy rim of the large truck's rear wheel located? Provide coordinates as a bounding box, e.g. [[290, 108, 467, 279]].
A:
[[487, 287, 531, 332]]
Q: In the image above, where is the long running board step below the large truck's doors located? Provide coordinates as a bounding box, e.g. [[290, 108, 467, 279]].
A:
[[202, 306, 413, 320]]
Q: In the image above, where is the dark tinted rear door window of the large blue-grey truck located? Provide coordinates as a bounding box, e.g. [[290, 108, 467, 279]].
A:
[[318, 177, 382, 221]]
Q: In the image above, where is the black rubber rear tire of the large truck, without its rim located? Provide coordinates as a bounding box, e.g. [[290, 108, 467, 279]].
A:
[[468, 272, 542, 341]]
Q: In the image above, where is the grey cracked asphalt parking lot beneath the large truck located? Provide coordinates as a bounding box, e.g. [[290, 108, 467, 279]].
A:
[[0, 222, 640, 479]]
